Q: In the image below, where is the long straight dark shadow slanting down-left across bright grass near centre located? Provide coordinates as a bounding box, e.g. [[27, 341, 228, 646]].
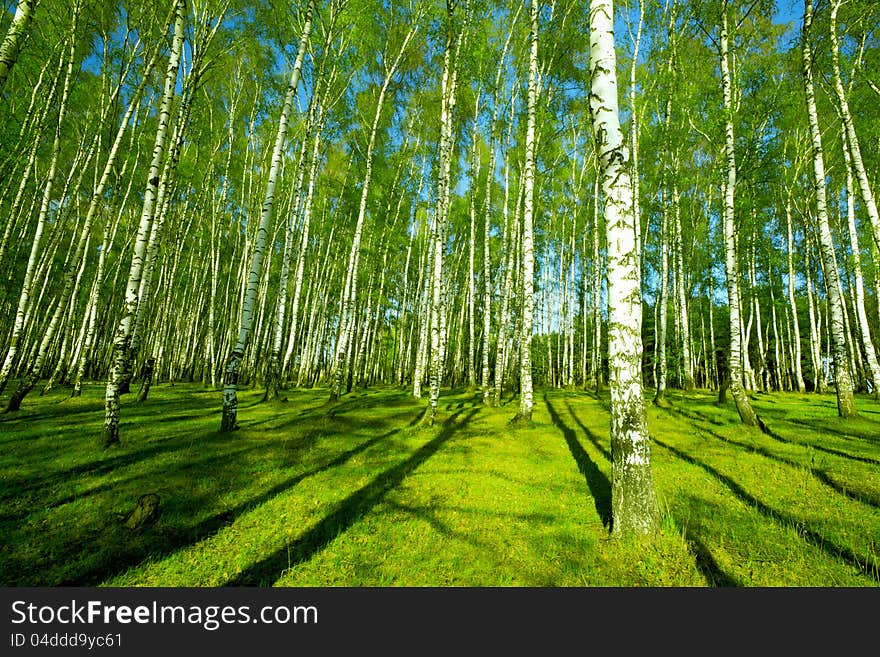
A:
[[226, 408, 479, 586]]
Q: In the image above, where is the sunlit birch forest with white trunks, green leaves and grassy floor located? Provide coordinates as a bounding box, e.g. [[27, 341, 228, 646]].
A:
[[0, 0, 880, 586]]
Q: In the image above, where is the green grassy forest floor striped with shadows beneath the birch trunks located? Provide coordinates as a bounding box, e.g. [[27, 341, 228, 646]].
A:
[[0, 384, 880, 587]]
